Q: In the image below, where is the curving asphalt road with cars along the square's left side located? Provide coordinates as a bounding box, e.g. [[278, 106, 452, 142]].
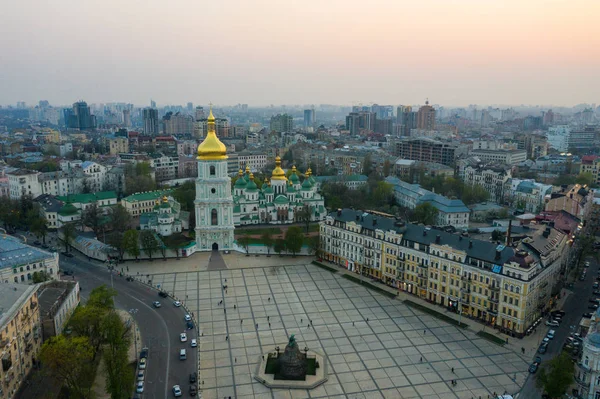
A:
[[60, 255, 198, 399]]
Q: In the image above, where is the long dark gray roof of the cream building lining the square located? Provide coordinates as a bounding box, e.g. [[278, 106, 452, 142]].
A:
[[329, 209, 515, 265]]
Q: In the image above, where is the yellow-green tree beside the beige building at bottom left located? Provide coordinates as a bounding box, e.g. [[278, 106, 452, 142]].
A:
[[40, 335, 95, 398]]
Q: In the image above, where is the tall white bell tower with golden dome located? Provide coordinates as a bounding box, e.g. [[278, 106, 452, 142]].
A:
[[194, 109, 235, 251]]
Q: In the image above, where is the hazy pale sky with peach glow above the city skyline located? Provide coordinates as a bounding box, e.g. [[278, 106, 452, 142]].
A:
[[0, 0, 600, 106]]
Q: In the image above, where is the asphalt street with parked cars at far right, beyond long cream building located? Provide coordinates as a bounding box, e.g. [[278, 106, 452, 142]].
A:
[[519, 258, 598, 399]]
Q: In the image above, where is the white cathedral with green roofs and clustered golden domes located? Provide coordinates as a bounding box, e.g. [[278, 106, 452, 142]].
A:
[[233, 157, 327, 226]]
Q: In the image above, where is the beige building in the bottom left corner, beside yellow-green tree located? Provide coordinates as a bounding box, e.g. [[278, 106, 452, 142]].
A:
[[0, 283, 42, 399]]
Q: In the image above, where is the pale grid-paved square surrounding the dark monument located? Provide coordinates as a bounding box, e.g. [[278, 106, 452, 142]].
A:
[[153, 265, 527, 399]]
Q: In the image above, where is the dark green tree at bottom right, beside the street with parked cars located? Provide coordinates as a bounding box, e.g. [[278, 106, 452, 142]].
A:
[[536, 351, 575, 398]]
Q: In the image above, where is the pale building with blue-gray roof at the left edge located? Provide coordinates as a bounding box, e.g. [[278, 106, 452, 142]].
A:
[[0, 235, 58, 284]]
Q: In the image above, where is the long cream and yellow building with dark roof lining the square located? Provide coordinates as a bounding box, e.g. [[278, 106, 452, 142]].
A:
[[320, 209, 568, 337]]
